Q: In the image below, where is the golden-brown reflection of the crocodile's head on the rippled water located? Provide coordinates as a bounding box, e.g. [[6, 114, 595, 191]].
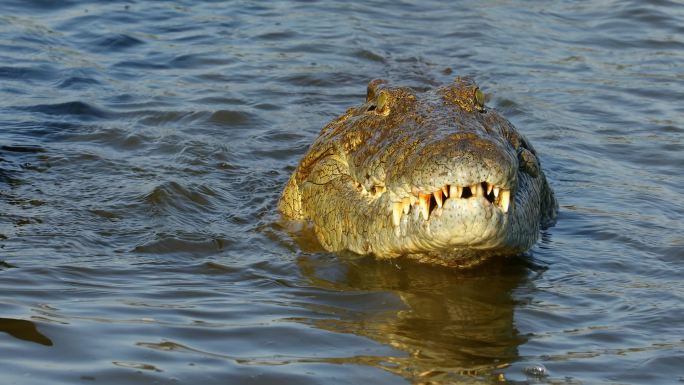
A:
[[298, 256, 530, 384]]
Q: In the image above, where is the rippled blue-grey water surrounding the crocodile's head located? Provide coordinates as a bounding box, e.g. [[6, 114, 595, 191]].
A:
[[0, 0, 684, 384]]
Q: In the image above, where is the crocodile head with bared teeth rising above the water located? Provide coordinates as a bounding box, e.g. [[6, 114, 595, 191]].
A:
[[278, 77, 558, 268]]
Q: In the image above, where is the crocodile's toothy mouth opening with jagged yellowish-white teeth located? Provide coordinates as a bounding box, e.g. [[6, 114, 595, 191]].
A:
[[392, 181, 511, 229]]
